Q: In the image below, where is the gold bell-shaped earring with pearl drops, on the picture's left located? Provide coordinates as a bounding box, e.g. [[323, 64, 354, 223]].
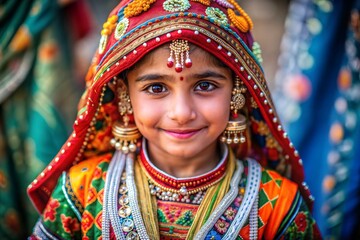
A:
[[110, 79, 141, 154]]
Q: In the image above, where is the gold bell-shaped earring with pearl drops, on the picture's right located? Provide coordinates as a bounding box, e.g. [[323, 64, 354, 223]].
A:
[[220, 76, 246, 144]]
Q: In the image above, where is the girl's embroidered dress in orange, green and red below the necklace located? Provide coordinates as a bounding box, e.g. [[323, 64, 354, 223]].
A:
[[34, 145, 317, 239]]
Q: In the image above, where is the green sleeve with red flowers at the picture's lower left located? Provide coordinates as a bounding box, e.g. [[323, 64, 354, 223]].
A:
[[29, 172, 81, 239]]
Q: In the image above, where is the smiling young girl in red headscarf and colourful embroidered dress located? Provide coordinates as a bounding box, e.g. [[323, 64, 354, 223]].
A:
[[28, 0, 320, 239]]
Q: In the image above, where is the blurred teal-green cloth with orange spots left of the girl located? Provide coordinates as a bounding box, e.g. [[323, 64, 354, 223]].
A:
[[0, 0, 81, 239]]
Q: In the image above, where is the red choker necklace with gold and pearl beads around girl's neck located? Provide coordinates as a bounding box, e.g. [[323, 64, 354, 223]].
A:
[[139, 141, 228, 204]]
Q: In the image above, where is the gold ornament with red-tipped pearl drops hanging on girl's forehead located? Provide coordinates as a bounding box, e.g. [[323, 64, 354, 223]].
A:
[[167, 39, 192, 72]]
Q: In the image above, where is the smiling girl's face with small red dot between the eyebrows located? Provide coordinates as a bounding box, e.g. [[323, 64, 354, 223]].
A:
[[127, 44, 233, 159]]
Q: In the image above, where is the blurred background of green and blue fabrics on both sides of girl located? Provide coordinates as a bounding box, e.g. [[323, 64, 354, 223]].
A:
[[0, 0, 360, 239]]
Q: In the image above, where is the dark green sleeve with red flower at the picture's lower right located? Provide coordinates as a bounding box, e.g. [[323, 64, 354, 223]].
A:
[[276, 192, 322, 240]]
